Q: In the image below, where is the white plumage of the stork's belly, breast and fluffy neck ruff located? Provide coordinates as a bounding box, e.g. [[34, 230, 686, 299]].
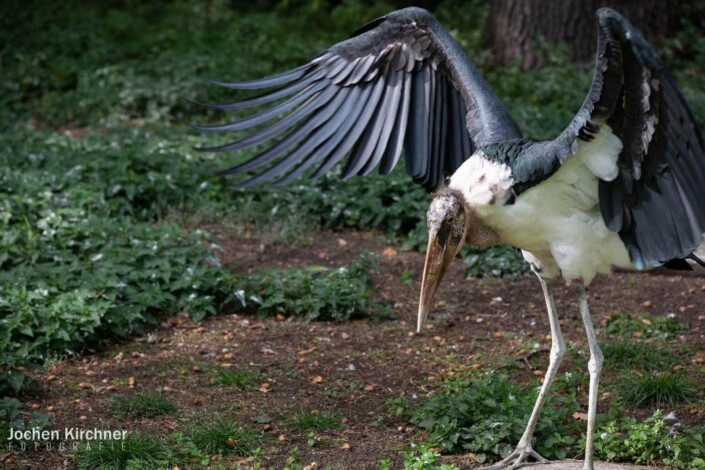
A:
[[449, 125, 632, 284]]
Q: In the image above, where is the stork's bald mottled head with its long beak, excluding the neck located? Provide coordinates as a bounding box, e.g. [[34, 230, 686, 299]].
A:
[[417, 188, 468, 332]]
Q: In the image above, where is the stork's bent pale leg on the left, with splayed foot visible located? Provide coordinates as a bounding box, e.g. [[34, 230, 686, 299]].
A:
[[486, 273, 565, 470]]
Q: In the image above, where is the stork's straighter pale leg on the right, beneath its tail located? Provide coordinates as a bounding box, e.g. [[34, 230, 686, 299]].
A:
[[577, 283, 604, 470]]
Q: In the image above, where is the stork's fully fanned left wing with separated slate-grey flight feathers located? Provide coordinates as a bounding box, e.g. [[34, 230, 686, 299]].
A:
[[199, 8, 521, 189]]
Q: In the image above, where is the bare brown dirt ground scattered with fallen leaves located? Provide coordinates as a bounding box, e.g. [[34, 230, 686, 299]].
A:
[[5, 227, 705, 469]]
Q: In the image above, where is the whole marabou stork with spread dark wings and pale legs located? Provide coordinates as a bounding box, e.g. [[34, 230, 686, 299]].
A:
[[192, 8, 705, 469]]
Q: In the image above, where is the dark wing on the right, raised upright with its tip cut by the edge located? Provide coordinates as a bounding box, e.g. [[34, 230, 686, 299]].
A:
[[553, 8, 705, 269]]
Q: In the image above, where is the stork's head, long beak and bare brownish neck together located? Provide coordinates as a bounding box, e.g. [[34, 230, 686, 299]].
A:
[[417, 188, 499, 332]]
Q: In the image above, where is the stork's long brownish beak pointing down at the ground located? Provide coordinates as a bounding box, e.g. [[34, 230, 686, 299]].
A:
[[416, 231, 462, 333]]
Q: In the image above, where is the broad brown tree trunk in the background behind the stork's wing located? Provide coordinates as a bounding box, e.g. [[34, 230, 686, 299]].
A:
[[484, 0, 683, 69]]
